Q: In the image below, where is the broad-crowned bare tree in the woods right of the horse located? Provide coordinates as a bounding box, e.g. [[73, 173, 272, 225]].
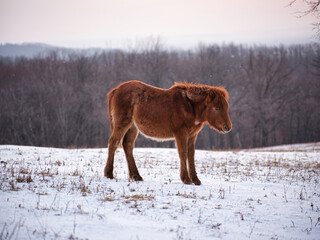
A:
[[243, 48, 293, 146]]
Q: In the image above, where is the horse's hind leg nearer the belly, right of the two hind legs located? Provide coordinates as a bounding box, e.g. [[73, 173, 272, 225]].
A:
[[122, 124, 143, 181]]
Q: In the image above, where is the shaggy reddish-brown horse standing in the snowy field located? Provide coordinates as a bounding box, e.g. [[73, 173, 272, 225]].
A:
[[104, 81, 231, 185]]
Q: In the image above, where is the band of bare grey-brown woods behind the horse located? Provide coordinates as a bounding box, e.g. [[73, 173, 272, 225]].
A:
[[0, 41, 320, 149]]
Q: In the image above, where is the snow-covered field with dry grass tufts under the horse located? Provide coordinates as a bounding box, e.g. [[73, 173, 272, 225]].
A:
[[0, 143, 320, 240]]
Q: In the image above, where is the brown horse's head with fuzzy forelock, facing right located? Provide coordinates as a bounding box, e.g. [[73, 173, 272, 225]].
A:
[[187, 87, 232, 133]]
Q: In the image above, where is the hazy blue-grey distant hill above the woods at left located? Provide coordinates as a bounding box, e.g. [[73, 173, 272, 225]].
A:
[[0, 43, 117, 58]]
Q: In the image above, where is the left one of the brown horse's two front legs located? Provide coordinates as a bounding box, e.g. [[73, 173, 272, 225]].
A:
[[175, 134, 192, 184]]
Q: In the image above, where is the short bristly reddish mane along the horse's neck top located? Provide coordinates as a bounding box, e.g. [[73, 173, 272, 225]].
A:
[[173, 82, 229, 101]]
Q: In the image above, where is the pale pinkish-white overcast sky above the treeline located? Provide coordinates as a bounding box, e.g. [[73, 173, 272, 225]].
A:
[[0, 0, 316, 48]]
